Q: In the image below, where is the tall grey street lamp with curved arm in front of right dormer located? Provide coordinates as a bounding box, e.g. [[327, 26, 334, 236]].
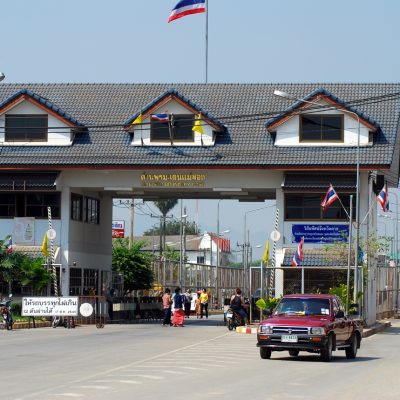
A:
[[274, 90, 361, 303]]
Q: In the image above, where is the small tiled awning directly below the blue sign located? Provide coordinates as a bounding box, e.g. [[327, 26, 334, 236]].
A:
[[281, 247, 354, 268]]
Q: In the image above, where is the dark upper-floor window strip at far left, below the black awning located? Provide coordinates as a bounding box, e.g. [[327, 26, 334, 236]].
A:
[[0, 193, 60, 218]]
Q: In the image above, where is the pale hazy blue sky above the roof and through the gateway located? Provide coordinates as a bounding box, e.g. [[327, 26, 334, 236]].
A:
[[0, 0, 400, 258]]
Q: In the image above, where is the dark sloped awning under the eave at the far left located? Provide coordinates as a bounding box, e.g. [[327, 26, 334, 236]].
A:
[[0, 172, 58, 191]]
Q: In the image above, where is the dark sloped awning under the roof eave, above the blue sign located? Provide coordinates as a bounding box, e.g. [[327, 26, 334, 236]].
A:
[[282, 172, 357, 192]]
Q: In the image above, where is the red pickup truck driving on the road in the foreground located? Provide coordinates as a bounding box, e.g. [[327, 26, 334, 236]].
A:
[[257, 294, 363, 361]]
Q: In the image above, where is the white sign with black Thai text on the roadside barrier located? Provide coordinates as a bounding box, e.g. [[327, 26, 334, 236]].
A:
[[21, 297, 79, 317]]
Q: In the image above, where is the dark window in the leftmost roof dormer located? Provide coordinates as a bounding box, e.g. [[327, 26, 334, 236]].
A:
[[5, 114, 48, 142]]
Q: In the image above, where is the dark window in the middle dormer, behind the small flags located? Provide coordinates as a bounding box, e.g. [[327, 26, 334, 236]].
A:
[[150, 114, 194, 142]]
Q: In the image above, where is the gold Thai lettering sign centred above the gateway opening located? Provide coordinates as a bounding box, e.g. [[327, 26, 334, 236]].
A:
[[140, 173, 206, 187]]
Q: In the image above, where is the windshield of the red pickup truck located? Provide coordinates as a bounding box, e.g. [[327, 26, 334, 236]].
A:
[[274, 298, 330, 315]]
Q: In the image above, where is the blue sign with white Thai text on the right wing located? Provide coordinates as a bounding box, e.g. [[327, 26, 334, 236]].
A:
[[292, 224, 349, 243]]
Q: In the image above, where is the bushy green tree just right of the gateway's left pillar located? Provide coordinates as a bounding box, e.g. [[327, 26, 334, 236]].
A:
[[112, 239, 154, 290]]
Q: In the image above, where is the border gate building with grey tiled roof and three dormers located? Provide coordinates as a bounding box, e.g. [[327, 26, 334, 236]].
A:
[[0, 83, 400, 320]]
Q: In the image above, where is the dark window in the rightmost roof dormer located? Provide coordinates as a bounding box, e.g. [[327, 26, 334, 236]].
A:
[[300, 115, 343, 142]]
